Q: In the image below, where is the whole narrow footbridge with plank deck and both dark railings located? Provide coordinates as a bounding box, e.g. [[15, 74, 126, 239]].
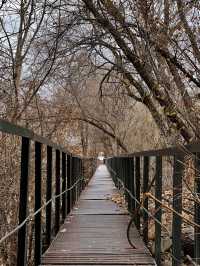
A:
[[0, 120, 200, 266]]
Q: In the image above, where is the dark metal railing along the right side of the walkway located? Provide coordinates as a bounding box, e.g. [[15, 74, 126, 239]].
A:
[[106, 147, 200, 266]]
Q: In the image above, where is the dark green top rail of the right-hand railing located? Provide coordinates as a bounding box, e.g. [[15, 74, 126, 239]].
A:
[[107, 142, 200, 159]]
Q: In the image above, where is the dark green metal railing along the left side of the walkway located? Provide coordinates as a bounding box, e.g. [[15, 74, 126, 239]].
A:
[[0, 120, 90, 266]]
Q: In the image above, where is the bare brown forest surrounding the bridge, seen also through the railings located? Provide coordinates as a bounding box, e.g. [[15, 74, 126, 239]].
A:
[[0, 0, 200, 266]]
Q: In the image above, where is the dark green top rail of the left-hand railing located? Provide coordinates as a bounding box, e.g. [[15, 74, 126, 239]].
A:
[[0, 119, 74, 157]]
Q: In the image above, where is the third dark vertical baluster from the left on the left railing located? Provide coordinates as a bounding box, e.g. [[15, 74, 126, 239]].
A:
[[46, 146, 52, 248]]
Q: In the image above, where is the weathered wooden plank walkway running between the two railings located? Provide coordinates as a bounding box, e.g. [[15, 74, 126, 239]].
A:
[[42, 165, 156, 266]]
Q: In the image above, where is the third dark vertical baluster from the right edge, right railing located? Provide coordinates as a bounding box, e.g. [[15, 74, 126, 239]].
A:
[[155, 156, 162, 265]]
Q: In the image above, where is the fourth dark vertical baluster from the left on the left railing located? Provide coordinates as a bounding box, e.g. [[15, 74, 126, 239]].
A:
[[55, 150, 60, 234]]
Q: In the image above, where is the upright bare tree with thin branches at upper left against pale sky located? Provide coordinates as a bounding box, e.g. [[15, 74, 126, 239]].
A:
[[0, 0, 78, 122]]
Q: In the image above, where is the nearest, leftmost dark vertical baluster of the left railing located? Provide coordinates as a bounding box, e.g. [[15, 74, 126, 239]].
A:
[[17, 137, 30, 266]]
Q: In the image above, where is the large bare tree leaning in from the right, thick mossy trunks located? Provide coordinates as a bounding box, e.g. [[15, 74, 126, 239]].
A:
[[62, 0, 200, 143]]
